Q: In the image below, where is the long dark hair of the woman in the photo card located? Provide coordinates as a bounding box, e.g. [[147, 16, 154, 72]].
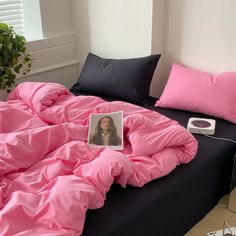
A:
[[90, 116, 121, 146]]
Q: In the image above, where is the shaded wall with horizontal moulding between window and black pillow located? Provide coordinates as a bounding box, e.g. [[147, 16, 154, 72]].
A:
[[20, 0, 79, 93]]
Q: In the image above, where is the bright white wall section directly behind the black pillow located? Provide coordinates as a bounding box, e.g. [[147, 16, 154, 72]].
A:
[[73, 0, 152, 70]]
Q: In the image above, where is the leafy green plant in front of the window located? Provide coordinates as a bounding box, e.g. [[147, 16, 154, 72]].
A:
[[0, 22, 32, 92]]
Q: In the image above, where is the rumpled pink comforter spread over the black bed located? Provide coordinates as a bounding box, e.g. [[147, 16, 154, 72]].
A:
[[0, 82, 197, 236]]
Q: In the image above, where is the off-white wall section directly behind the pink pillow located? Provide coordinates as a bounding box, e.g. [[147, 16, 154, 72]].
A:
[[163, 0, 236, 90]]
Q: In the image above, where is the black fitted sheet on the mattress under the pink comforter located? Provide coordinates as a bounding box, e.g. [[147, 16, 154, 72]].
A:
[[72, 91, 236, 236]]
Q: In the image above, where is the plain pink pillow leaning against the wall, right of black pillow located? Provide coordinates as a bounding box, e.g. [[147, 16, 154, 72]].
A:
[[156, 63, 236, 123]]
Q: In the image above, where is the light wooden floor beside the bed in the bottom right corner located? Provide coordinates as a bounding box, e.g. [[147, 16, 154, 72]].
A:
[[185, 196, 236, 236]]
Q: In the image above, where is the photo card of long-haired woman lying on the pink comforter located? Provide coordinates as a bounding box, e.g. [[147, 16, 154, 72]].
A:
[[88, 111, 123, 150]]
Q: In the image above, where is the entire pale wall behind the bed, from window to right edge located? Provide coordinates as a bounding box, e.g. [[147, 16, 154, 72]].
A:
[[4, 0, 236, 101]]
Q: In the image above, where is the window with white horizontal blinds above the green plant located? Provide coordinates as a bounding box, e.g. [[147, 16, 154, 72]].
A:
[[0, 0, 25, 34]]
